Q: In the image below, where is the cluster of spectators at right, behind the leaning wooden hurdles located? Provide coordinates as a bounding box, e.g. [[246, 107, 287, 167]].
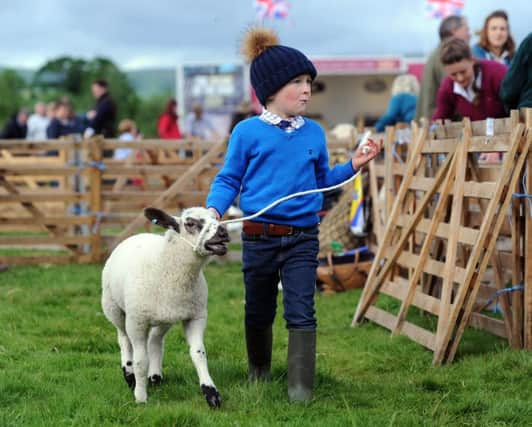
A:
[[376, 10, 532, 140]]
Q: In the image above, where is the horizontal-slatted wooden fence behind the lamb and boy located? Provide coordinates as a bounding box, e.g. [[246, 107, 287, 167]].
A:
[[0, 132, 355, 264]]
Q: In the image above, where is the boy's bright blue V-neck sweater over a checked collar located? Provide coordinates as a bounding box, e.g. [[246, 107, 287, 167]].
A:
[[207, 117, 354, 227]]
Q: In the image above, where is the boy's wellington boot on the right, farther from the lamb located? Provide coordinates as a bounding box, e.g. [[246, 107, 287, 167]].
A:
[[288, 329, 316, 402]]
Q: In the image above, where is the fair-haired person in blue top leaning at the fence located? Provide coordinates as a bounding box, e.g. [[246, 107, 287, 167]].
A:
[[375, 74, 419, 132]]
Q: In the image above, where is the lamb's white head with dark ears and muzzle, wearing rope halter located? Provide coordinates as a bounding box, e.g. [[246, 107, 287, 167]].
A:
[[144, 207, 229, 256]]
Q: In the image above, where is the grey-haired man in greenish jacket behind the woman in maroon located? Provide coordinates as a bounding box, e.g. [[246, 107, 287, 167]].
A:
[[415, 15, 471, 120]]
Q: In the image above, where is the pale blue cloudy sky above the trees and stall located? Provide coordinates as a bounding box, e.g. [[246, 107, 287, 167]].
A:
[[0, 0, 532, 69]]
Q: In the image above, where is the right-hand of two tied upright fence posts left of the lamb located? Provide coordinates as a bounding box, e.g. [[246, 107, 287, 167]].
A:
[[88, 139, 103, 262]]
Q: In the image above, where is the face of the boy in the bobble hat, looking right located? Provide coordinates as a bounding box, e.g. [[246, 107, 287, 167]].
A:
[[267, 74, 312, 118]]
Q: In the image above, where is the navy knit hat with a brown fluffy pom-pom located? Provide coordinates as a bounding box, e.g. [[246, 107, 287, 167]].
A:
[[242, 28, 317, 105]]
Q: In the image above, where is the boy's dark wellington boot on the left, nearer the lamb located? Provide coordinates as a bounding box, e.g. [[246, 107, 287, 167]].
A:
[[246, 325, 272, 381]]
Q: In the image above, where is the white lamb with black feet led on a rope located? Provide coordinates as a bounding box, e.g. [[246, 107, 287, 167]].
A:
[[102, 208, 229, 408]]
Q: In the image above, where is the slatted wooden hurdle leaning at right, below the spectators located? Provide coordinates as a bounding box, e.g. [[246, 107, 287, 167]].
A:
[[353, 110, 530, 364]]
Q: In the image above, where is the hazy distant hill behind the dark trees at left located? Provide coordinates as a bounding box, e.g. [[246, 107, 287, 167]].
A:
[[0, 67, 176, 98]]
